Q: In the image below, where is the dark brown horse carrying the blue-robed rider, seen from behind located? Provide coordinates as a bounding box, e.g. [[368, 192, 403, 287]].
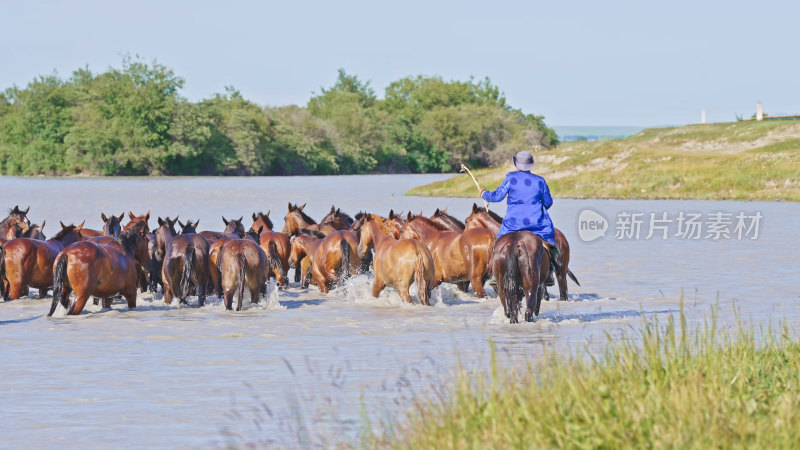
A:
[[491, 231, 550, 323]]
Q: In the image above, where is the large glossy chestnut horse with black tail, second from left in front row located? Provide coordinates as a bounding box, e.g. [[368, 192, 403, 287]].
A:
[[47, 225, 144, 316]]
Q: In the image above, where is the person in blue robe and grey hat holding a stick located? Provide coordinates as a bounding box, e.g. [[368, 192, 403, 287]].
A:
[[479, 151, 560, 286]]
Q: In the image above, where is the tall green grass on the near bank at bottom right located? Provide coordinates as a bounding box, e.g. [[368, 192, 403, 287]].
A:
[[372, 314, 800, 449]]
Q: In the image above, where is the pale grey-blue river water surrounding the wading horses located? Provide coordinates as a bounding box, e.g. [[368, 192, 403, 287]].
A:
[[0, 176, 800, 447]]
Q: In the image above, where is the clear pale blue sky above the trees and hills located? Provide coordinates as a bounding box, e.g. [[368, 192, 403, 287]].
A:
[[0, 0, 800, 126]]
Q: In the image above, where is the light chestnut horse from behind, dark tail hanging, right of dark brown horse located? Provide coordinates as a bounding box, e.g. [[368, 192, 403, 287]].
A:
[[219, 238, 267, 311]]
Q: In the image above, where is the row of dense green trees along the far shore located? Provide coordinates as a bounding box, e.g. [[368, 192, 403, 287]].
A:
[[0, 58, 557, 175]]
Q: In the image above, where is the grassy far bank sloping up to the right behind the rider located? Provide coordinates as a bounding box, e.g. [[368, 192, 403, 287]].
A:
[[407, 120, 800, 201]]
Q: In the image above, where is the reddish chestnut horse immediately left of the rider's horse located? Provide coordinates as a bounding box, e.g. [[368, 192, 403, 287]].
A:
[[400, 213, 495, 298]]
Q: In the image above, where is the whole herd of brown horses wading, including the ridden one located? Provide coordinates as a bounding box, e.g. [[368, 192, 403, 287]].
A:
[[0, 203, 578, 323]]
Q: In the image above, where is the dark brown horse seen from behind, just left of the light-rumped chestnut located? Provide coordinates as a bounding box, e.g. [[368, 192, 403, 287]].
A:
[[161, 221, 209, 306]]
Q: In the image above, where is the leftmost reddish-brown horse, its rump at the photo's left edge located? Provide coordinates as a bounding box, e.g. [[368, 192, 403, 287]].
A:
[[0, 223, 83, 300]]
